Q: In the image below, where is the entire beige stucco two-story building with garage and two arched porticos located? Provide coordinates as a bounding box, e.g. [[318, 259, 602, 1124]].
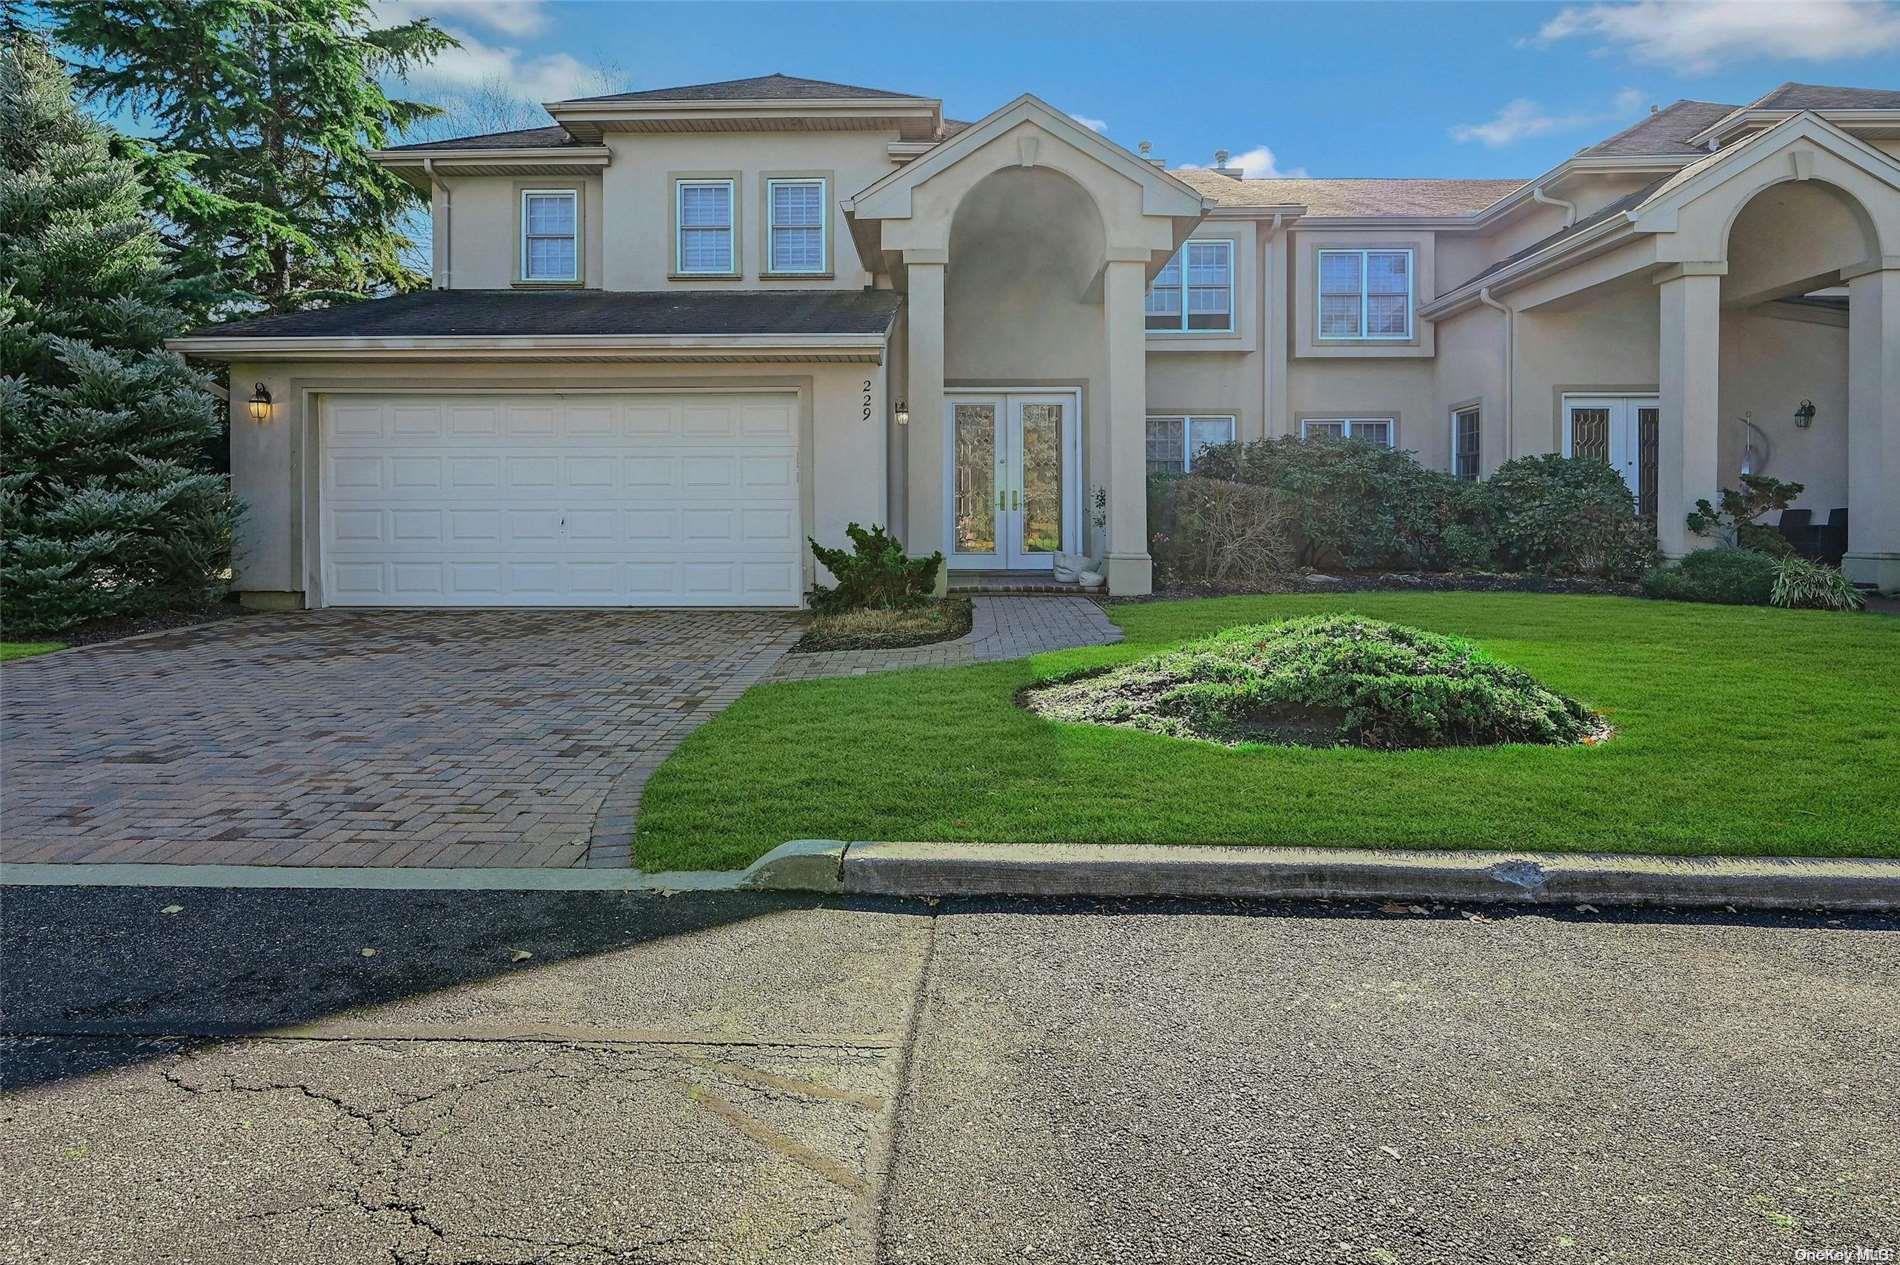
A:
[[173, 74, 1900, 606]]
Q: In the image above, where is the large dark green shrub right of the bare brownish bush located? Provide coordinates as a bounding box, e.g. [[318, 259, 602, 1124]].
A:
[[1195, 437, 1461, 570]]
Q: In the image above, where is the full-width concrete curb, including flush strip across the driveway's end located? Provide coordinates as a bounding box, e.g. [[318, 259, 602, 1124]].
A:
[[14, 840, 1900, 914]]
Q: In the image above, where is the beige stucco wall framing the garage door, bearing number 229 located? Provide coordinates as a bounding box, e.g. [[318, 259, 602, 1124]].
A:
[[232, 361, 891, 593]]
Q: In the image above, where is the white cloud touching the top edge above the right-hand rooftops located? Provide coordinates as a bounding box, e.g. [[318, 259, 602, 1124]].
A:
[[1526, 0, 1900, 74]]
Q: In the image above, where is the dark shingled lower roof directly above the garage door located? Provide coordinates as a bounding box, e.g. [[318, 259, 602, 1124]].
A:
[[186, 291, 901, 338]]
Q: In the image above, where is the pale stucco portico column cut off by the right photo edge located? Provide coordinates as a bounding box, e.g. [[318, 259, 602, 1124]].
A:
[[1839, 255, 1900, 591]]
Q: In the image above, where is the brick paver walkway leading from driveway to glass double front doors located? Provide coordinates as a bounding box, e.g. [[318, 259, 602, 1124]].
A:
[[771, 593, 1121, 680]]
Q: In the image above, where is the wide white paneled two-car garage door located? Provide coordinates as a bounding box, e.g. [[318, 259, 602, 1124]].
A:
[[319, 393, 804, 606]]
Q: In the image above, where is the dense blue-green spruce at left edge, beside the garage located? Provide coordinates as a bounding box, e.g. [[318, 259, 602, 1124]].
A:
[[0, 30, 238, 634]]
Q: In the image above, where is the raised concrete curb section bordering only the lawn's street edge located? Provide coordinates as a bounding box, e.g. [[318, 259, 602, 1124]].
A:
[[741, 840, 1900, 912]]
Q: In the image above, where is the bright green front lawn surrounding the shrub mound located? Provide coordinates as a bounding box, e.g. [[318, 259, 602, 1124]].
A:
[[637, 593, 1900, 870]]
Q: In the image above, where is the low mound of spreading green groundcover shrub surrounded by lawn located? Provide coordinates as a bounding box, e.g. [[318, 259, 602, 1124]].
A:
[[1022, 615, 1607, 750]]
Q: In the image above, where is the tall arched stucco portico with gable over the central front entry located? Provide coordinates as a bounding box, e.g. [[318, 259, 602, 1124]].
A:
[[847, 97, 1203, 595]]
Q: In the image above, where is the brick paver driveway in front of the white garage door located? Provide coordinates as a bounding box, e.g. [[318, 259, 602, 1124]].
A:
[[0, 610, 798, 866]]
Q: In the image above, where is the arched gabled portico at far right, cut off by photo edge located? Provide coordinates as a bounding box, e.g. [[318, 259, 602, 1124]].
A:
[[1636, 114, 1900, 589]]
